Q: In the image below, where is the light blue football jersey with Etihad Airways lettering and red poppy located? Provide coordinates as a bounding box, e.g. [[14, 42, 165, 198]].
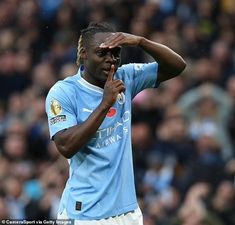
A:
[[46, 63, 158, 220]]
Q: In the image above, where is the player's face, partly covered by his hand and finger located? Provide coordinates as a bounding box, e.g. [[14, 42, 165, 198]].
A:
[[83, 33, 121, 88]]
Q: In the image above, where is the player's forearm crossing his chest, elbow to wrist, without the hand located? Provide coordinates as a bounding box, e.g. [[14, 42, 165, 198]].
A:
[[54, 103, 110, 158]]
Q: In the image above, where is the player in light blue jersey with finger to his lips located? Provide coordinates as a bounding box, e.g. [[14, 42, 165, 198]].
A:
[[46, 23, 185, 225]]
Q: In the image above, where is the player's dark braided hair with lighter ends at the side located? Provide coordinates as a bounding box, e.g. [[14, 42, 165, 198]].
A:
[[77, 22, 116, 66]]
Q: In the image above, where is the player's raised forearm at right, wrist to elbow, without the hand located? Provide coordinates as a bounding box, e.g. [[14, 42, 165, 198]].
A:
[[139, 38, 186, 82]]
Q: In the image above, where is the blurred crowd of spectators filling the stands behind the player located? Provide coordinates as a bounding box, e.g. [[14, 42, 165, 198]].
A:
[[0, 0, 235, 225]]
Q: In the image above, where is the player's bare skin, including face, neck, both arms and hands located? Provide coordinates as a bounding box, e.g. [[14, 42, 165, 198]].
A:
[[54, 32, 186, 158]]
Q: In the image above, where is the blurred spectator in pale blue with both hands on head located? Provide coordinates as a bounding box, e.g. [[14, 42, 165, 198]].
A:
[[179, 84, 232, 159]]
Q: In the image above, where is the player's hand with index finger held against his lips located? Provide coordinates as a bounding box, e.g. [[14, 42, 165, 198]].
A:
[[102, 65, 125, 107]]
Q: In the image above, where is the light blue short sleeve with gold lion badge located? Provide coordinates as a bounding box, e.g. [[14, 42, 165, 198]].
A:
[[45, 82, 77, 138]]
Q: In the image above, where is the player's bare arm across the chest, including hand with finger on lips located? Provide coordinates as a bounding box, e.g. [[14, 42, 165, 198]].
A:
[[54, 66, 125, 158]]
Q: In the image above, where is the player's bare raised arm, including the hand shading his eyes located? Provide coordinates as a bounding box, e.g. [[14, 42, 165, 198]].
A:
[[100, 32, 186, 82]]
